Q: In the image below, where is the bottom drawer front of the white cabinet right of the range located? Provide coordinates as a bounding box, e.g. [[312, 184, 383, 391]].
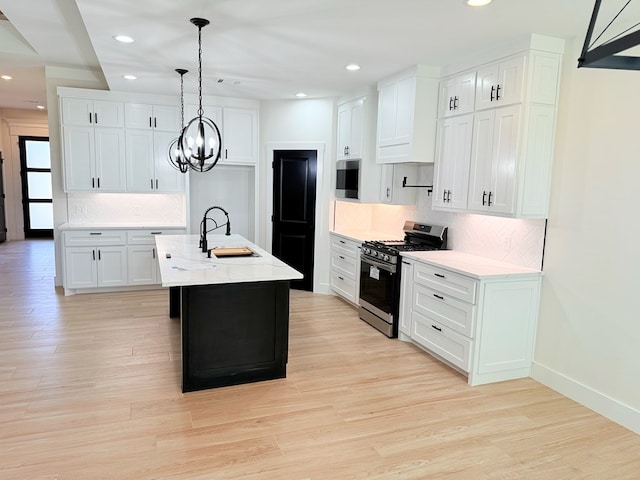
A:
[[411, 311, 472, 373]]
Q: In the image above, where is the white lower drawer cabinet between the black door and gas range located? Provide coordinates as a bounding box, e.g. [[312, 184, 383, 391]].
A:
[[330, 233, 360, 305]]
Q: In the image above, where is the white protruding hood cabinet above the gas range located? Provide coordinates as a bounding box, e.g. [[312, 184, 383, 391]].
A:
[[376, 66, 438, 163]]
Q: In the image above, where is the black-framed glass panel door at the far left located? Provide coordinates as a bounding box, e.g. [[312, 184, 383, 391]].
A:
[[19, 137, 53, 238]]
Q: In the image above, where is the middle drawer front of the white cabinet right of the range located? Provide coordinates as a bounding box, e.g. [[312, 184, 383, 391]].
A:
[[413, 284, 476, 338]]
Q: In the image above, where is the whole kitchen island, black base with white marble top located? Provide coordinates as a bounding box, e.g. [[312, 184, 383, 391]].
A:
[[156, 235, 302, 392]]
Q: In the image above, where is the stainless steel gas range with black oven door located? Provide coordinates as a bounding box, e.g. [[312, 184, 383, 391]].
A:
[[360, 221, 448, 338]]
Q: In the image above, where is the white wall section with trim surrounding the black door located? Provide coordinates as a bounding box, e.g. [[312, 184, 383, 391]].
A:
[[257, 99, 335, 292]]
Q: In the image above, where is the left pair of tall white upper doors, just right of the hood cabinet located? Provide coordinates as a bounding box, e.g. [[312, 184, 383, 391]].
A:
[[432, 114, 473, 210]]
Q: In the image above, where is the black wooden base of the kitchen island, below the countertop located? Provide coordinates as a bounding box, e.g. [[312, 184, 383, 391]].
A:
[[178, 280, 289, 392]]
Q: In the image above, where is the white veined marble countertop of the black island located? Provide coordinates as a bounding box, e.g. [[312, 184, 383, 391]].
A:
[[155, 235, 303, 287]]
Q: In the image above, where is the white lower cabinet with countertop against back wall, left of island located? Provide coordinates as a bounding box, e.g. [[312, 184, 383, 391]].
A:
[[63, 229, 184, 295]]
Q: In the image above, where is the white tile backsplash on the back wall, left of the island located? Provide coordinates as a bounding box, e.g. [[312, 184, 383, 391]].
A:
[[67, 193, 187, 226]]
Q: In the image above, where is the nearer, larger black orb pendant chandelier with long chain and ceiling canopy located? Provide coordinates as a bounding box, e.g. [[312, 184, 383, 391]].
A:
[[178, 18, 222, 172]]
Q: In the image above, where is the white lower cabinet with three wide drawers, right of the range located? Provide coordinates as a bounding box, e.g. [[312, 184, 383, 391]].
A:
[[399, 254, 541, 385]]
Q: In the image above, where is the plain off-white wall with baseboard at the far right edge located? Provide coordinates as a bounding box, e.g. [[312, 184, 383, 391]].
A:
[[534, 39, 640, 433]]
